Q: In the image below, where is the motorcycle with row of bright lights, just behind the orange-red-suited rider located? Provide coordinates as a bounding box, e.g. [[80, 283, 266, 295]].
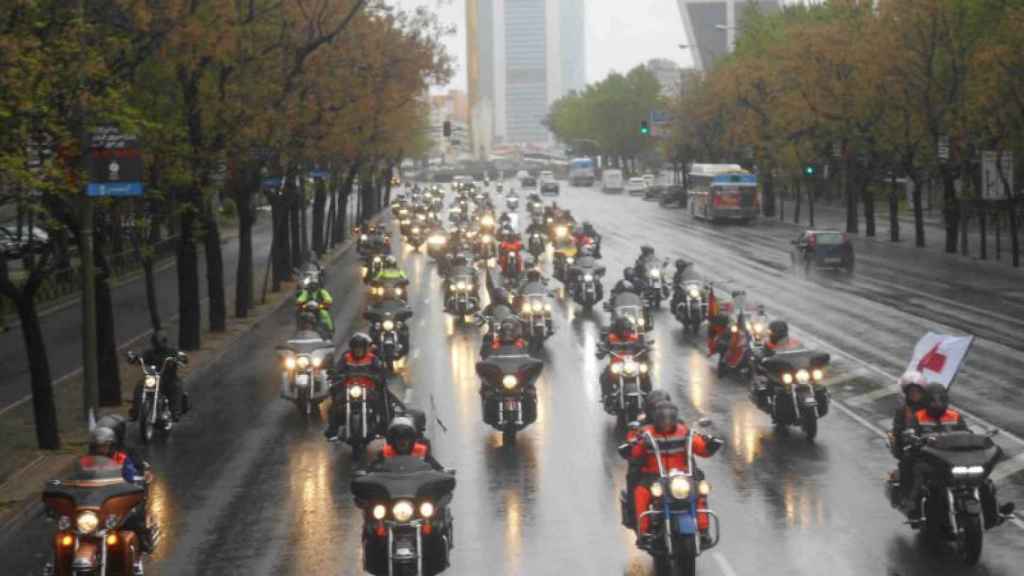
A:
[[597, 342, 651, 429]]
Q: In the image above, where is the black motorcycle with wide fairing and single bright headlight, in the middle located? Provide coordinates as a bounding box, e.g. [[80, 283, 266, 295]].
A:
[[476, 342, 544, 445]]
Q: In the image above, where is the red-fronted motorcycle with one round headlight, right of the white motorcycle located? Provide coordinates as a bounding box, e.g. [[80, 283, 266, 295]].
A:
[[331, 370, 391, 460]]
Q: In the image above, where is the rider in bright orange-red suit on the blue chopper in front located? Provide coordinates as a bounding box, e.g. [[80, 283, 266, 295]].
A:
[[620, 402, 723, 545]]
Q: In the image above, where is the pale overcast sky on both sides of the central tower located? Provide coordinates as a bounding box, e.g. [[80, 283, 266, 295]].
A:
[[390, 0, 691, 90]]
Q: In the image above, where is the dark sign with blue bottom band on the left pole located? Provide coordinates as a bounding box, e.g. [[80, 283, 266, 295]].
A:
[[85, 126, 142, 198]]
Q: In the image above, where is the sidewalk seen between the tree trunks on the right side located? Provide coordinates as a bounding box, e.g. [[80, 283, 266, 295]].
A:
[[773, 201, 1024, 271]]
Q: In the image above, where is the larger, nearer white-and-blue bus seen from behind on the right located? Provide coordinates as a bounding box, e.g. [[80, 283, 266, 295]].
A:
[[686, 164, 760, 222]]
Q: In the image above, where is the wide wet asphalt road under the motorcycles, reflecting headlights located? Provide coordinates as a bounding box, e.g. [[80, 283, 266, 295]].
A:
[[0, 183, 1024, 576]]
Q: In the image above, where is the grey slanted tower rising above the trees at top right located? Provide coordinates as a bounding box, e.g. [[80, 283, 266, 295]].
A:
[[677, 0, 781, 70]]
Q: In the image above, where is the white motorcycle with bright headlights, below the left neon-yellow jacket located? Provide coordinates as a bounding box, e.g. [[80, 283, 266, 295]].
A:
[[275, 338, 335, 416]]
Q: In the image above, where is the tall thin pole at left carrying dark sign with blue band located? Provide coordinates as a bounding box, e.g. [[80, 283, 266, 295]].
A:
[[76, 0, 99, 421]]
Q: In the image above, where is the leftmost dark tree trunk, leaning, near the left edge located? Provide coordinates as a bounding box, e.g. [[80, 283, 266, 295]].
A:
[[15, 290, 60, 450]]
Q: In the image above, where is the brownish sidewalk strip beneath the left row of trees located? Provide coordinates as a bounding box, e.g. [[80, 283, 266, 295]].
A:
[[0, 215, 366, 532]]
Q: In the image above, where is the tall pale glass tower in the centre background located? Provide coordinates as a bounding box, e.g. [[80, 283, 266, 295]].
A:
[[466, 0, 586, 147]]
